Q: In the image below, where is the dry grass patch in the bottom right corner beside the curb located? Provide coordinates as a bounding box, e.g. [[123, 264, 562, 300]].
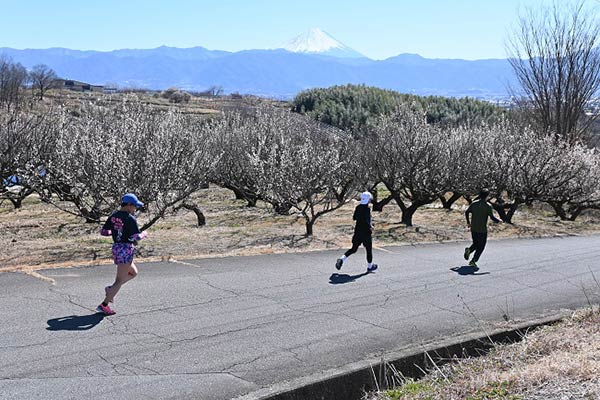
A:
[[370, 308, 600, 400]]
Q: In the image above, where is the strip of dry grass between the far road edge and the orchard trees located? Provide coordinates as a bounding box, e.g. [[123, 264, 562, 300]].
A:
[[0, 187, 600, 272]]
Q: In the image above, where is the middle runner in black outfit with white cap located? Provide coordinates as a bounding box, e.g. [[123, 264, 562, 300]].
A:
[[335, 192, 377, 272]]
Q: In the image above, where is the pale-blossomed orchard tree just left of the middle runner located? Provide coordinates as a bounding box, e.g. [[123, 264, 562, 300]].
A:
[[249, 108, 357, 236]]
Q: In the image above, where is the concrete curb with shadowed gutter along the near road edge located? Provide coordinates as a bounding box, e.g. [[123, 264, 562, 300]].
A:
[[235, 312, 568, 400]]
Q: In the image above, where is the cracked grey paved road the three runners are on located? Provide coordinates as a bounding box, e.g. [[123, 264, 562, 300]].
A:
[[0, 236, 600, 399]]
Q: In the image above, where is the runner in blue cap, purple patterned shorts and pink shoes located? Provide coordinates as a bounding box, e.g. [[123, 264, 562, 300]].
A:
[[96, 193, 148, 315]]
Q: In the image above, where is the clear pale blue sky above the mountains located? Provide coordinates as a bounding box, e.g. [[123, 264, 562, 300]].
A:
[[0, 0, 576, 59]]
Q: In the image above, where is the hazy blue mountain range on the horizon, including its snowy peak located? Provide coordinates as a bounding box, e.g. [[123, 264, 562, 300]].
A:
[[0, 29, 514, 98]]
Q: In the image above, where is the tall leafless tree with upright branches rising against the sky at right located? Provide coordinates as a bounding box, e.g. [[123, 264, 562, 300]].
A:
[[507, 1, 600, 144]]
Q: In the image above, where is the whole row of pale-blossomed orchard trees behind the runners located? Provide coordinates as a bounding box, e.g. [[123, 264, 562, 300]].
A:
[[0, 100, 600, 235]]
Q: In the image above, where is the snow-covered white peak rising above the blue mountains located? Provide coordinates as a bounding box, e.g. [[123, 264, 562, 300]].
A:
[[281, 28, 365, 58]]
